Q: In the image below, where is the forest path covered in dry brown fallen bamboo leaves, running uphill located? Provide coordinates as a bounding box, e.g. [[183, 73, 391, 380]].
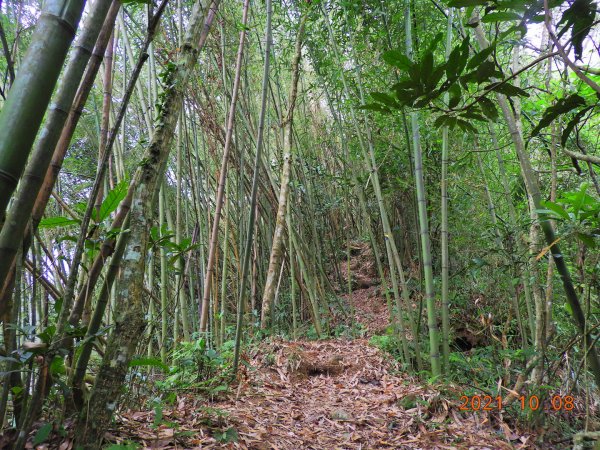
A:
[[96, 243, 535, 450]]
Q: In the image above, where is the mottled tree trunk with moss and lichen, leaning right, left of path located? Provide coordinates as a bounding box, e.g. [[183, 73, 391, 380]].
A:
[[76, 1, 216, 449]]
